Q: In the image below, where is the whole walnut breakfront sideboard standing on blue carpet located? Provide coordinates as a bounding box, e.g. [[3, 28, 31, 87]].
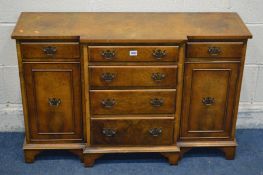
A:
[[12, 12, 252, 167]]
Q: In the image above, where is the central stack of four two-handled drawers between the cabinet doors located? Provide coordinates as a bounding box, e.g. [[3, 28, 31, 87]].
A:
[[88, 46, 179, 146]]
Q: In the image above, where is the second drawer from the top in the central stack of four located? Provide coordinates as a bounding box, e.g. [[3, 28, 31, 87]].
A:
[[90, 66, 177, 89]]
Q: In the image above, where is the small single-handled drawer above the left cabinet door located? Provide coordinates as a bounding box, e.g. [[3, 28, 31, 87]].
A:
[[21, 42, 80, 60]]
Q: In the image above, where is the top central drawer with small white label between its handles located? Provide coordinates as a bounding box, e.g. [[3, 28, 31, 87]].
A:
[[89, 46, 179, 62]]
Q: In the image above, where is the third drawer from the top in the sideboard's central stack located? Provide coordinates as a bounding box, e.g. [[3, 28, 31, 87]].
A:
[[90, 89, 176, 114]]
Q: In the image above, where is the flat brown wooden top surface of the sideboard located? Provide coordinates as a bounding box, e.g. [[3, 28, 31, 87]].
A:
[[12, 12, 252, 43]]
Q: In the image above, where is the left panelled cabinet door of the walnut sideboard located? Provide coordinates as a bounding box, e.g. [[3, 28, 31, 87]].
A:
[[24, 63, 83, 142]]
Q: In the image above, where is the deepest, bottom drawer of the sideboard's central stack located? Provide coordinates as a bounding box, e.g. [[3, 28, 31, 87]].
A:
[[91, 119, 174, 146]]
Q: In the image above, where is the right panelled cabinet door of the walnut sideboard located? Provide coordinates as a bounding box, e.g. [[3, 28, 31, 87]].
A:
[[181, 63, 240, 139]]
